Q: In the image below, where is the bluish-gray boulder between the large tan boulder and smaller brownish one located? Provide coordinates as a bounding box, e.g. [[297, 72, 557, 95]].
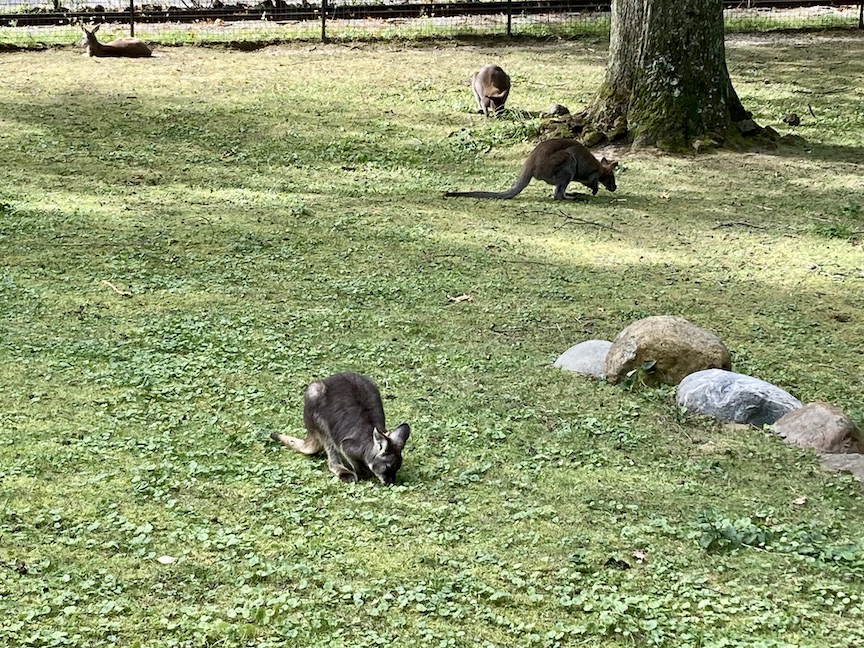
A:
[[678, 369, 801, 427]]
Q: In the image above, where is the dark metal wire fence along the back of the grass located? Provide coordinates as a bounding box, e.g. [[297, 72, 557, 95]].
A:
[[0, 0, 864, 46]]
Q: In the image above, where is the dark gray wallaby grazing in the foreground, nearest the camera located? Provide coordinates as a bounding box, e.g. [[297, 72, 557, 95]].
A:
[[270, 373, 411, 485]]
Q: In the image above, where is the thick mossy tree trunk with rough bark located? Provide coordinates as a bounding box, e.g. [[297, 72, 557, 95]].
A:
[[584, 0, 750, 150]]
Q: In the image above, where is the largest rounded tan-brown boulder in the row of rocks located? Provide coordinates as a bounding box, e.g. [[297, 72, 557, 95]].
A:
[[606, 315, 732, 385]]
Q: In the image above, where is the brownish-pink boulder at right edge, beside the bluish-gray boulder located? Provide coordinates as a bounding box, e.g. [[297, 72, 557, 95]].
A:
[[774, 402, 864, 453]]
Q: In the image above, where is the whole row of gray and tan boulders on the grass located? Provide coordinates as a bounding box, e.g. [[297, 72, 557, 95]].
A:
[[554, 315, 864, 481]]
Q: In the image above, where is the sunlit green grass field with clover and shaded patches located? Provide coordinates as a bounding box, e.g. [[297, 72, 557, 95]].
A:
[[0, 35, 864, 648]]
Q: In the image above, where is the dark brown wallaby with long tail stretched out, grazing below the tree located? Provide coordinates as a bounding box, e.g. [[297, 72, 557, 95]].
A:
[[444, 139, 618, 200]]
